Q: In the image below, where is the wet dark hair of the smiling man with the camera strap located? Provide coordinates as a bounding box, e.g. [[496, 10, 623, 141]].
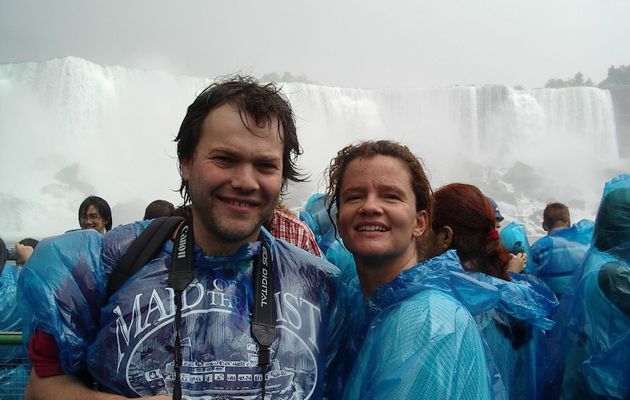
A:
[[174, 76, 306, 204]]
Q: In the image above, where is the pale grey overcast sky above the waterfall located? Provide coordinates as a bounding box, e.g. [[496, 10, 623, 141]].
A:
[[0, 0, 630, 88]]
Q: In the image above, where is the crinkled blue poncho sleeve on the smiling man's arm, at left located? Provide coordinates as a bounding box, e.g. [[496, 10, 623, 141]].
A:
[[19, 230, 105, 374]]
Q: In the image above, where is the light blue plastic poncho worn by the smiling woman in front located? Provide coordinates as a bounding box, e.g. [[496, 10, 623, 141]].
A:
[[344, 250, 557, 399]]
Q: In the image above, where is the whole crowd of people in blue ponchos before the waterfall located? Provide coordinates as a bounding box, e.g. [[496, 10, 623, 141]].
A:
[[0, 76, 630, 400]]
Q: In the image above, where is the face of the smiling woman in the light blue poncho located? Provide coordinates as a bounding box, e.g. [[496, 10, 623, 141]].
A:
[[337, 155, 427, 265]]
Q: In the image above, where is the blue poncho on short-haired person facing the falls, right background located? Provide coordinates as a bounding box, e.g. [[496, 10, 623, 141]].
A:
[[527, 219, 593, 297]]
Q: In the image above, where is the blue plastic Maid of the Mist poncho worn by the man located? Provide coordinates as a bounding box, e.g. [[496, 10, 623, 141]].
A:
[[20, 222, 346, 399]]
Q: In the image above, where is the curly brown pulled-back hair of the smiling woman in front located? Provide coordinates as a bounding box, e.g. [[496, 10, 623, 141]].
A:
[[326, 140, 433, 220]]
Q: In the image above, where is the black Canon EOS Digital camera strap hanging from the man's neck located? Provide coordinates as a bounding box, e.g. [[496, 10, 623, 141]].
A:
[[168, 218, 276, 400]]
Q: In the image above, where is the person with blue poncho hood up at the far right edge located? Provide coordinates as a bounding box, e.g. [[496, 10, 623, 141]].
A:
[[561, 175, 630, 399]]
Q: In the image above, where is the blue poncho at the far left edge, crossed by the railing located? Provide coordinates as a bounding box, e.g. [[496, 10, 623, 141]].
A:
[[0, 264, 30, 398]]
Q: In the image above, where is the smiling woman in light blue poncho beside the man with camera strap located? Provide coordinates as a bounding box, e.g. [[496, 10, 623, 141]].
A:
[[328, 141, 492, 399]]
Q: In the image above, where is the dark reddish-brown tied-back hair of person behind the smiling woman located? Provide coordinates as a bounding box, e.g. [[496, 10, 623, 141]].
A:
[[432, 183, 510, 280]]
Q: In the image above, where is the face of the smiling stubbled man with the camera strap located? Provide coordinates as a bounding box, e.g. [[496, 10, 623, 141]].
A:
[[182, 104, 284, 253]]
